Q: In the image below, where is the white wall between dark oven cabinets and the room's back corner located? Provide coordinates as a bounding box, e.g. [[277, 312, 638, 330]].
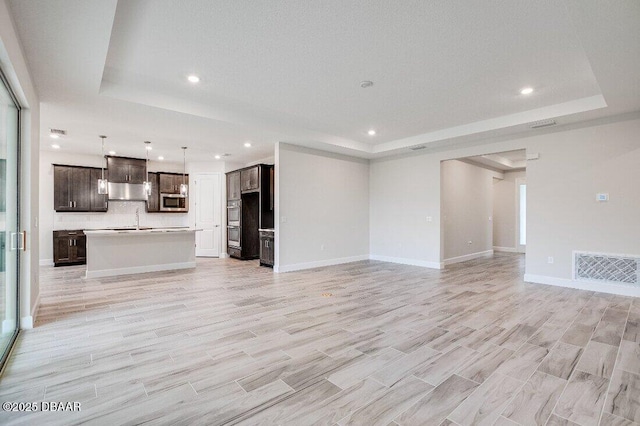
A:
[[274, 143, 369, 272]]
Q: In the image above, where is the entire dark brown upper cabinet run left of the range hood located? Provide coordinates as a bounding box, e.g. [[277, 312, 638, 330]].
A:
[[53, 164, 108, 212]]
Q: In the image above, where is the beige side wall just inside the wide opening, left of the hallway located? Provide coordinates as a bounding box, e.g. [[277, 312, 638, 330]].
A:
[[441, 160, 493, 264]]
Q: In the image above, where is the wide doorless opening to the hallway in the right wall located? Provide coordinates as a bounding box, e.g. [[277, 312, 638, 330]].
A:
[[441, 149, 527, 267]]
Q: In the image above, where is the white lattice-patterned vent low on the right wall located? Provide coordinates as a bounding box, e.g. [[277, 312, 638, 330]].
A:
[[574, 252, 640, 285]]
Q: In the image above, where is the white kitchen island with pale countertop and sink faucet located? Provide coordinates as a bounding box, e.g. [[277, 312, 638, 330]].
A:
[[84, 228, 196, 278]]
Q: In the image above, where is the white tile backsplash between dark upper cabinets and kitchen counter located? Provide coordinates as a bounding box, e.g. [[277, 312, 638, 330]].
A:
[[53, 201, 189, 230]]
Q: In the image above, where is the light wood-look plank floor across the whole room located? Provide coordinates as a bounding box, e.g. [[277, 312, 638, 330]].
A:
[[0, 254, 640, 426]]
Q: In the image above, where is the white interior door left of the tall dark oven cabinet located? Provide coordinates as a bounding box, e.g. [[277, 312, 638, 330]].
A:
[[192, 173, 222, 257]]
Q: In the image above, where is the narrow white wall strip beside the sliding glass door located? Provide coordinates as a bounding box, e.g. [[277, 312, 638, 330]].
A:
[[0, 0, 40, 328]]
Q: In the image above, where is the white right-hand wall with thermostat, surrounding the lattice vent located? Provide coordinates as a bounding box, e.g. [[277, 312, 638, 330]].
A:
[[525, 119, 640, 288]]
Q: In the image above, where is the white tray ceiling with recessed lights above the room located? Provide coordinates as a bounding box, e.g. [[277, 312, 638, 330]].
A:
[[9, 0, 640, 162]]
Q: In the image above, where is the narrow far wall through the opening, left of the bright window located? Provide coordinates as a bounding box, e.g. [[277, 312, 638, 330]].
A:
[[493, 171, 526, 252]]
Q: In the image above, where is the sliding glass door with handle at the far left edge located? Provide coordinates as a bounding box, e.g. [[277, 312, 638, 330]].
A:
[[0, 70, 19, 366]]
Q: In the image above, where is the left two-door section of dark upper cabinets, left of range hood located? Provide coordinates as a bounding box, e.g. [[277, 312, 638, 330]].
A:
[[53, 165, 90, 212]]
